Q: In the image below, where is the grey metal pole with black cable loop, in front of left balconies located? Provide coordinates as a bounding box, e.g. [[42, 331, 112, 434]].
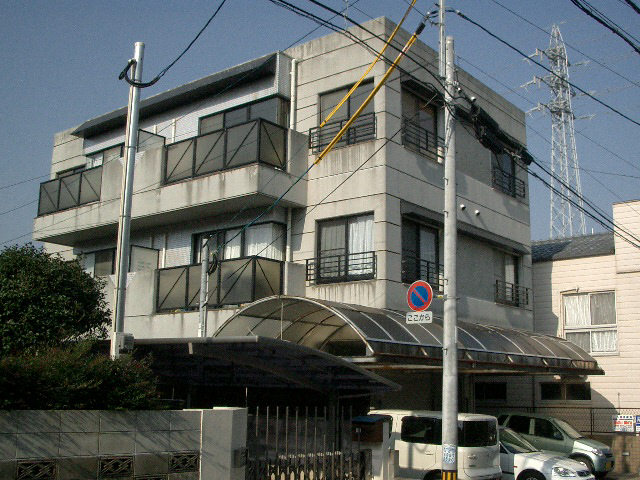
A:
[[111, 42, 144, 358]]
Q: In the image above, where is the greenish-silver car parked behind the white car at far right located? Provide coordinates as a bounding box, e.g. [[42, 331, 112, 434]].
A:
[[498, 413, 615, 477]]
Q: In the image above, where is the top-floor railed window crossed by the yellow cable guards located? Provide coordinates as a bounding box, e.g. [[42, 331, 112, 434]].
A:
[[309, 82, 376, 153]]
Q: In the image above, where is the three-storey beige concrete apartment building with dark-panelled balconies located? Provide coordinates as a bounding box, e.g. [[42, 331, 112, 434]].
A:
[[34, 18, 597, 408]]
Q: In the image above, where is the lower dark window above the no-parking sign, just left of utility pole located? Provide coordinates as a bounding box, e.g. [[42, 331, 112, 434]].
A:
[[402, 219, 444, 291]]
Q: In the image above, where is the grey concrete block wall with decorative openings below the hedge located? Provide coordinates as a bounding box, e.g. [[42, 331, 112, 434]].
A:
[[0, 408, 247, 480]]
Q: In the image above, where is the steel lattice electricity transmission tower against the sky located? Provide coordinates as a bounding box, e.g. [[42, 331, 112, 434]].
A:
[[529, 25, 586, 238]]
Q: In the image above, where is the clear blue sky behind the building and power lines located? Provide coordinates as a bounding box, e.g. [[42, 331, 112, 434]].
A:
[[0, 0, 640, 248]]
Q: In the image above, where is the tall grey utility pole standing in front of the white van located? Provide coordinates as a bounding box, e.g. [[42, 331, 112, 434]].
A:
[[441, 37, 458, 480]]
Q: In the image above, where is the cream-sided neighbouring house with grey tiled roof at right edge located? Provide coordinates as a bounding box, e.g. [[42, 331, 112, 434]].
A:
[[532, 200, 640, 414]]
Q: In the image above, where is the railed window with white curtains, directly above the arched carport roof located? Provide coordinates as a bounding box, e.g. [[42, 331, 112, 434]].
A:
[[314, 214, 375, 282]]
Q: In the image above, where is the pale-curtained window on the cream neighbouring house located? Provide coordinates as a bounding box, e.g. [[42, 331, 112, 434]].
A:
[[563, 292, 618, 354]]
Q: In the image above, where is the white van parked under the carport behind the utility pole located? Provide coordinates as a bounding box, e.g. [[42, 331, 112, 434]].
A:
[[369, 410, 502, 480]]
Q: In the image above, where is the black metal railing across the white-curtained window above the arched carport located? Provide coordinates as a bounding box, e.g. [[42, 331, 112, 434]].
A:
[[306, 252, 376, 284]]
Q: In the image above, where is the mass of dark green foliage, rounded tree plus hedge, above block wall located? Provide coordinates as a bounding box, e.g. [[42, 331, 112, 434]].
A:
[[0, 244, 161, 410]]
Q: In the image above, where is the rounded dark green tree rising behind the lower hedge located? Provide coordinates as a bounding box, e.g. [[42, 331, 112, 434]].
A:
[[0, 244, 110, 354]]
